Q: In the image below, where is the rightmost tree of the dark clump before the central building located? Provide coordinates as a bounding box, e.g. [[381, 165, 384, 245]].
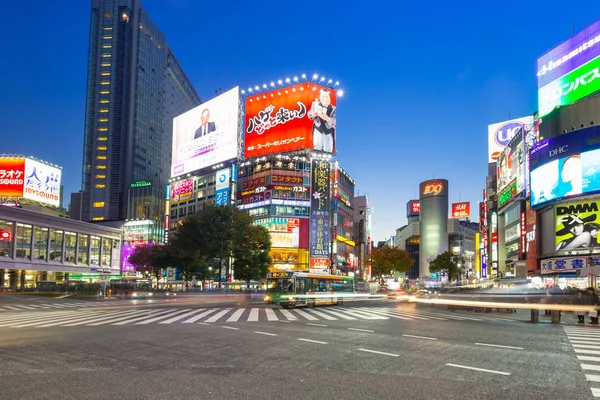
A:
[[233, 226, 271, 283]]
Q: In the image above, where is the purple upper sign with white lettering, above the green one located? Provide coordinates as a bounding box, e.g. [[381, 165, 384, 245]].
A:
[[537, 20, 600, 88]]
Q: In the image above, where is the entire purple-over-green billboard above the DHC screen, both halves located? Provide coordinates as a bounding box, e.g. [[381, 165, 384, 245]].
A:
[[537, 20, 600, 117]]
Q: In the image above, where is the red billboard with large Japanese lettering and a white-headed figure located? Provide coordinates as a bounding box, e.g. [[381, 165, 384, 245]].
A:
[[244, 82, 337, 158]]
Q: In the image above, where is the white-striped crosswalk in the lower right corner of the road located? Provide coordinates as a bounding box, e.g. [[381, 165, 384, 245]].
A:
[[563, 326, 600, 397]]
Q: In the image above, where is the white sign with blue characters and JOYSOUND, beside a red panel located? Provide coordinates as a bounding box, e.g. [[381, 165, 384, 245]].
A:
[[23, 158, 62, 207]]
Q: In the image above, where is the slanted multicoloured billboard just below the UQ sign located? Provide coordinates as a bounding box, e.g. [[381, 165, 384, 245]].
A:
[[496, 134, 525, 194]]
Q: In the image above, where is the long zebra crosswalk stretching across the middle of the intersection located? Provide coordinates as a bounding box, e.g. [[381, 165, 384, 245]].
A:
[[0, 306, 513, 328]]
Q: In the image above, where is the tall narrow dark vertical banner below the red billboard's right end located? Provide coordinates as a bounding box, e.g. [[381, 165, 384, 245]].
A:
[[310, 159, 331, 259]]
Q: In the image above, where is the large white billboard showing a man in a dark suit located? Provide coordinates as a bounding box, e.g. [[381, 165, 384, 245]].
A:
[[171, 87, 240, 177]]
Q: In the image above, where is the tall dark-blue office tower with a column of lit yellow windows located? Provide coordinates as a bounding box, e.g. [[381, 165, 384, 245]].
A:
[[81, 0, 201, 221]]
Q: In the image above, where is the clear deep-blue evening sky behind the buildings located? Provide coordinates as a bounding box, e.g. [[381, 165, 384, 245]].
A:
[[0, 0, 598, 241]]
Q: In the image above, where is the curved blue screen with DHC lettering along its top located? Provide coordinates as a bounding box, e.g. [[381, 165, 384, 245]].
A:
[[530, 126, 600, 207]]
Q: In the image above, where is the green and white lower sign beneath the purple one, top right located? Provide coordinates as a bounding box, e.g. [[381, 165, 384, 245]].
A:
[[538, 53, 600, 117]]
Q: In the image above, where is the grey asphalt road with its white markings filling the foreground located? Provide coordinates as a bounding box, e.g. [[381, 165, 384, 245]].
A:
[[0, 301, 600, 400]]
